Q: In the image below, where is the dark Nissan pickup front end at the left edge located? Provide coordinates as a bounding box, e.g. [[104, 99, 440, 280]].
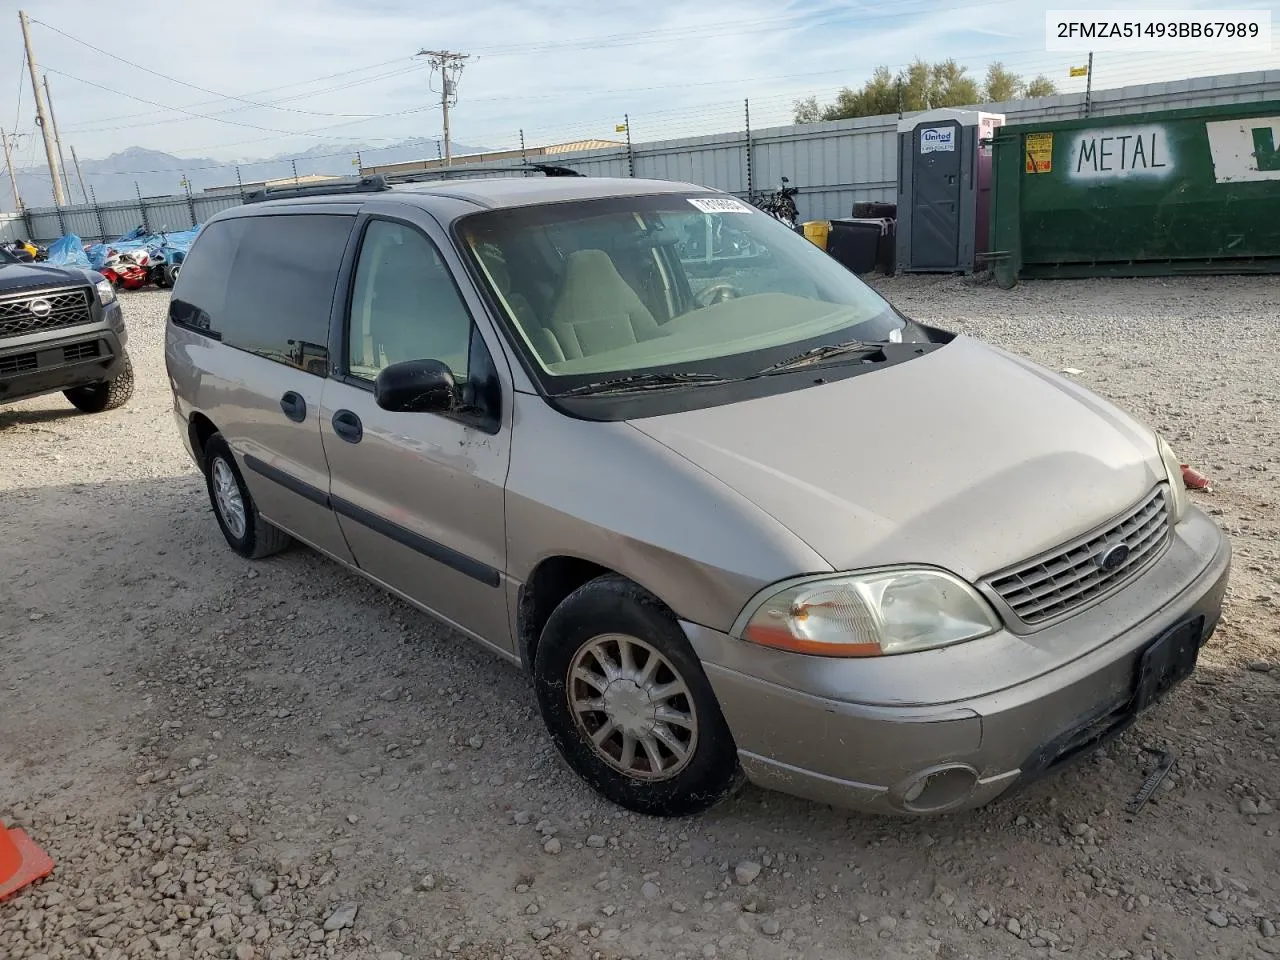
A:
[[0, 251, 133, 413]]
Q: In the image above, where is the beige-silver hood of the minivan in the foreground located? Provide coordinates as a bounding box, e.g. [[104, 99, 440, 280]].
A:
[[631, 337, 1165, 580]]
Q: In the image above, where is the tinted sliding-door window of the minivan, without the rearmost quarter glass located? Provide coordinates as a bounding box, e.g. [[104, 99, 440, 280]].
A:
[[215, 214, 355, 376]]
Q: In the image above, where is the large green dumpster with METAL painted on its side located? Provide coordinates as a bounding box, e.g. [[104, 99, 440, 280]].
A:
[[988, 101, 1280, 285]]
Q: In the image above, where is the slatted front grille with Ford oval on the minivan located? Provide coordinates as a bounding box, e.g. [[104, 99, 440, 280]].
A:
[[988, 486, 1169, 632]]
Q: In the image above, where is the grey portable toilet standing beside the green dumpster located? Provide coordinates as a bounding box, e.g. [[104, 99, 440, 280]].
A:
[[897, 108, 1005, 274]]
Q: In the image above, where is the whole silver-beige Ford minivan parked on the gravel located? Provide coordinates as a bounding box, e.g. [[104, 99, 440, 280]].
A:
[[165, 170, 1230, 815]]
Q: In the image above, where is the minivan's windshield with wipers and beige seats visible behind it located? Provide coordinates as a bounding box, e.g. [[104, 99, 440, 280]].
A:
[[458, 193, 911, 390]]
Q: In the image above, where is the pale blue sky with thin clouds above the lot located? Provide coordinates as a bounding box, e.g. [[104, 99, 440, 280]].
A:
[[0, 0, 1280, 168]]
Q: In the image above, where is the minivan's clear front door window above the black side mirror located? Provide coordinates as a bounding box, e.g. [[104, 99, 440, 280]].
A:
[[347, 220, 471, 383]]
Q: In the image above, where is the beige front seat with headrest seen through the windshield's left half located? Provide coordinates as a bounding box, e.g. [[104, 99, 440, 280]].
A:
[[547, 250, 664, 360]]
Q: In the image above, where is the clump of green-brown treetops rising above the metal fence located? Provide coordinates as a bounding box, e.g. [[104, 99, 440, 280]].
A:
[[792, 56, 1057, 123]]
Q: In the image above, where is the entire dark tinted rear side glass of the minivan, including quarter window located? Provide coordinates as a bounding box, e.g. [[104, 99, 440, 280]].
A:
[[169, 214, 355, 376]]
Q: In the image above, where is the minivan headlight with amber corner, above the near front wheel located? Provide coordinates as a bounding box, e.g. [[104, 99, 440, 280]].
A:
[[739, 567, 1000, 657]]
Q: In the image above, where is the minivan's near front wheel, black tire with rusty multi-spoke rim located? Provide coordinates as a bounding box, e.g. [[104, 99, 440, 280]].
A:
[[534, 575, 741, 817]]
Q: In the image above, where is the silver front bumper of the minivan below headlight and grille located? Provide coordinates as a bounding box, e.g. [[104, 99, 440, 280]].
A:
[[684, 509, 1231, 814]]
